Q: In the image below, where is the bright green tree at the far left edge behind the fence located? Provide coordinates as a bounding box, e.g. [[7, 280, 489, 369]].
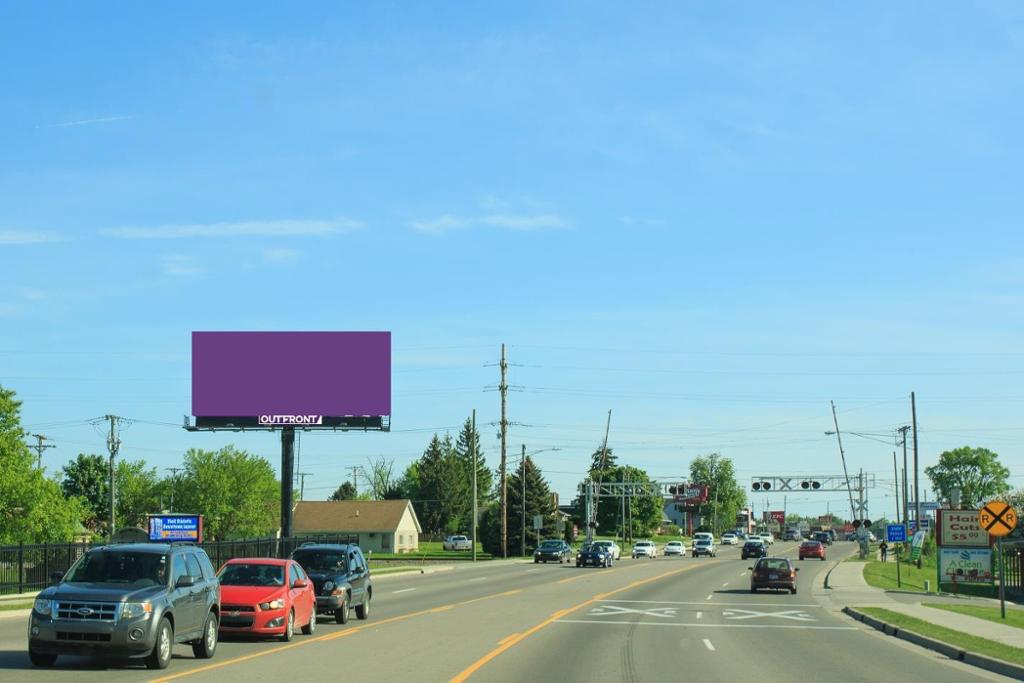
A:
[[0, 387, 85, 544]]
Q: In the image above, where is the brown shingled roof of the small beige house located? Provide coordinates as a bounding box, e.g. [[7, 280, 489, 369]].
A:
[[292, 500, 422, 533]]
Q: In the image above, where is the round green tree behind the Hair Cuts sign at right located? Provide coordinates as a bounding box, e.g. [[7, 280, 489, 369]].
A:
[[925, 445, 1010, 508]]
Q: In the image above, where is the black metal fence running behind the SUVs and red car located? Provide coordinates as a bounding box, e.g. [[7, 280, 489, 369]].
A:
[[0, 535, 358, 595]]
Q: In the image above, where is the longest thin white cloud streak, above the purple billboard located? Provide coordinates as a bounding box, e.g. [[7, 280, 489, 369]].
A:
[[99, 218, 362, 240]]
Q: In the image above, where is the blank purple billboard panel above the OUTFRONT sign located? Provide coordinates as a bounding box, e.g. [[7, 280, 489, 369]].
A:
[[193, 332, 391, 417]]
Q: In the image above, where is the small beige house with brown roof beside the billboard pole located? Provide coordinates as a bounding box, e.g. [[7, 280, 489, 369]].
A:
[[292, 500, 423, 553]]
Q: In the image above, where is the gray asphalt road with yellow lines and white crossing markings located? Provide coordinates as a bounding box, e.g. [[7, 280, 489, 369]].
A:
[[0, 543, 1009, 683]]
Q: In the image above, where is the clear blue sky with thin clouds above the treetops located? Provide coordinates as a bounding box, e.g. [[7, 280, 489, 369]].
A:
[[0, 2, 1024, 520]]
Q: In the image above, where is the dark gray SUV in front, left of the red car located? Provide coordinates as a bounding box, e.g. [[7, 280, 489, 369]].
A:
[[29, 543, 220, 669]]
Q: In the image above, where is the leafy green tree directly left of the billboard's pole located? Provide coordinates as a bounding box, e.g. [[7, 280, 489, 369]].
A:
[[174, 445, 280, 541]]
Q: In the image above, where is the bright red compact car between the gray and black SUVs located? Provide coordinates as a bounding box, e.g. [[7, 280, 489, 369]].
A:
[[217, 557, 316, 641]]
